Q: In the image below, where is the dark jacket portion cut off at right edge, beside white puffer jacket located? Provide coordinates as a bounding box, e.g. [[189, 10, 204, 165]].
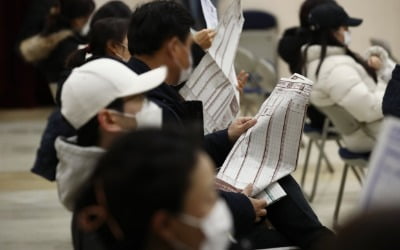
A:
[[382, 64, 400, 117]]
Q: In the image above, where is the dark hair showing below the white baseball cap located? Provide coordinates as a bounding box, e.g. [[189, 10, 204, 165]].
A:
[[76, 98, 124, 147]]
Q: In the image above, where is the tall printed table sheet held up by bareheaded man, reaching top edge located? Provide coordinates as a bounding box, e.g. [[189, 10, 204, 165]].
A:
[[180, 0, 244, 134]]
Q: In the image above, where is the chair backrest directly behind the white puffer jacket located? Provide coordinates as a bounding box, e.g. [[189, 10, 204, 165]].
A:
[[318, 105, 364, 135]]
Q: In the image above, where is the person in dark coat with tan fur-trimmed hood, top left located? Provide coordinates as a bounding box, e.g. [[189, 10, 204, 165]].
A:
[[19, 0, 95, 84]]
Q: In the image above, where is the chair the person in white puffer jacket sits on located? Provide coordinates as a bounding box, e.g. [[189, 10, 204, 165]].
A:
[[319, 105, 370, 227]]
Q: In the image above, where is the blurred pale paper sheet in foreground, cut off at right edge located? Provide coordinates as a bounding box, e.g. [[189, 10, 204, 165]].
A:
[[361, 117, 400, 211]]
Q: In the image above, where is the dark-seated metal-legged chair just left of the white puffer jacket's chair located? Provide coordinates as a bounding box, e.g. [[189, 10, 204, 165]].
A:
[[300, 118, 341, 202]]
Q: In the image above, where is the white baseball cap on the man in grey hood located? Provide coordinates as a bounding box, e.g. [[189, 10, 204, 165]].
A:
[[61, 58, 167, 129]]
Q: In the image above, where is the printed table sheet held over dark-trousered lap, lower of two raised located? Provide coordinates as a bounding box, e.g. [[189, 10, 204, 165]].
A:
[[217, 74, 312, 204]]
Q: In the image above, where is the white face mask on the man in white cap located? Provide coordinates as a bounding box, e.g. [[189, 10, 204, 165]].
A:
[[115, 98, 162, 129]]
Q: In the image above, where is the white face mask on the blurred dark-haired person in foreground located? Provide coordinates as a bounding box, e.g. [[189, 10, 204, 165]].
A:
[[180, 199, 233, 250]]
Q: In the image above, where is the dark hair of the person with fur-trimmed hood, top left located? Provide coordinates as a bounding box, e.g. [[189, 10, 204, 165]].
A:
[[42, 0, 96, 36]]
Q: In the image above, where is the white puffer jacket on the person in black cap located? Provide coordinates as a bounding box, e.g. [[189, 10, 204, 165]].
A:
[[306, 45, 386, 152]]
